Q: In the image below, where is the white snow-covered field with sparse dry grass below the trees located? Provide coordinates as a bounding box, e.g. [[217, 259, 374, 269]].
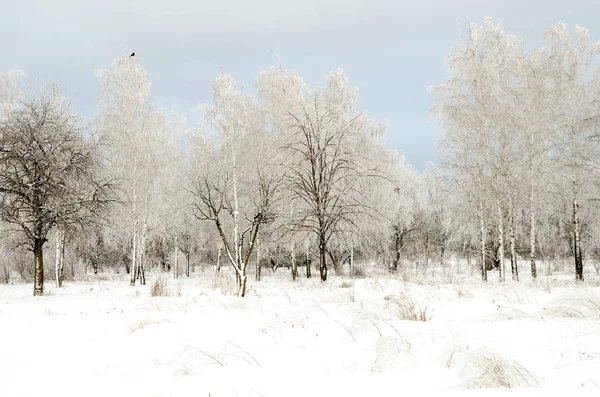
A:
[[0, 264, 600, 397]]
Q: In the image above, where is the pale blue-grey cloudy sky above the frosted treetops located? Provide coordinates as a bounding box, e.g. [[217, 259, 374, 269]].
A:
[[0, 0, 600, 169]]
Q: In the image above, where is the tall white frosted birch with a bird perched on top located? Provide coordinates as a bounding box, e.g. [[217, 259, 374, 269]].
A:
[[97, 56, 182, 285]]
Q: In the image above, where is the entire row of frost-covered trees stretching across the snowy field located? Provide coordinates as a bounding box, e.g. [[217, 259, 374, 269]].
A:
[[0, 20, 600, 296]]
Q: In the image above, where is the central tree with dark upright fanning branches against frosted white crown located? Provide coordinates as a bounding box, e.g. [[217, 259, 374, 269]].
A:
[[257, 68, 383, 281]]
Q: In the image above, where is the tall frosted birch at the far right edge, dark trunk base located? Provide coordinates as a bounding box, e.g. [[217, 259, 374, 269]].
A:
[[544, 23, 600, 281]]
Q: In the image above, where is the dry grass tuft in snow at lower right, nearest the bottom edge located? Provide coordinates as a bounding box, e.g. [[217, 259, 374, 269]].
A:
[[462, 348, 538, 389]]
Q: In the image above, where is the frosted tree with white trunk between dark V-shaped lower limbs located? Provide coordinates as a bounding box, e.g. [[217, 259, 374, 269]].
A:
[[190, 73, 282, 297]]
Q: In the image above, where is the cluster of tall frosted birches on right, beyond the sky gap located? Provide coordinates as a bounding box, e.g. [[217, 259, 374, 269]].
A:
[[432, 19, 600, 280]]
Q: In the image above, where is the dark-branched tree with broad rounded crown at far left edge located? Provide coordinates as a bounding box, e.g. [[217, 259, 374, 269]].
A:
[[0, 91, 110, 295]]
